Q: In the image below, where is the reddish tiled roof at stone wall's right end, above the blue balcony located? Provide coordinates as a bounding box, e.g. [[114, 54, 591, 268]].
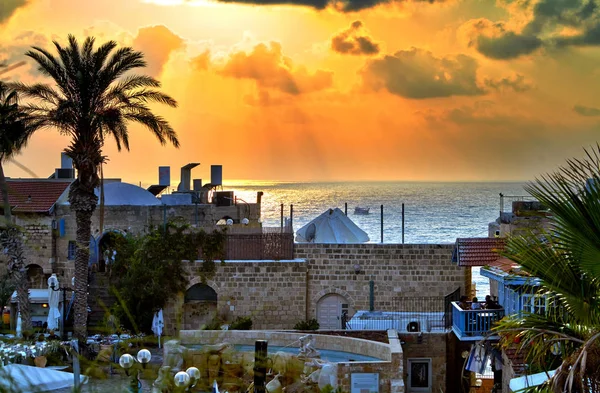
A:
[[452, 237, 506, 266]]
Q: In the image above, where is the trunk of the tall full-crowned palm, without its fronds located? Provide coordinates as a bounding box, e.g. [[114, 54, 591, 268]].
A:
[[69, 176, 98, 343]]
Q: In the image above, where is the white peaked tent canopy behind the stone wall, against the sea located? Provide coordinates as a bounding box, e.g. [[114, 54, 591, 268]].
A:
[[296, 208, 369, 243]]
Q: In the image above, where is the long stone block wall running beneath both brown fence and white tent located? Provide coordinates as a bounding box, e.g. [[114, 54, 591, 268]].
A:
[[165, 244, 469, 334]]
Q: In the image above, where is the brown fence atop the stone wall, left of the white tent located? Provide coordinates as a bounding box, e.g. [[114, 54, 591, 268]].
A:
[[200, 227, 294, 261]]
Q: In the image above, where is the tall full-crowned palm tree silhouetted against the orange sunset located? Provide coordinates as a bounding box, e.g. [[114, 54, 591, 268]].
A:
[[15, 35, 179, 342]]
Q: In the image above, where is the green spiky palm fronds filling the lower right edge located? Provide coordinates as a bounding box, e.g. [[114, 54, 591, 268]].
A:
[[497, 146, 600, 392]]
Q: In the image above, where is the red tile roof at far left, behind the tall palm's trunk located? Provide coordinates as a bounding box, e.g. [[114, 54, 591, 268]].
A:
[[0, 179, 71, 213]]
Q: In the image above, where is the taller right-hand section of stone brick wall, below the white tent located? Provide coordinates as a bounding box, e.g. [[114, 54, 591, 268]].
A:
[[294, 244, 470, 318]]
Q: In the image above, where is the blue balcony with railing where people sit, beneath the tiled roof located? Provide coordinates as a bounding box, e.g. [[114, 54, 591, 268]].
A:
[[452, 302, 504, 341]]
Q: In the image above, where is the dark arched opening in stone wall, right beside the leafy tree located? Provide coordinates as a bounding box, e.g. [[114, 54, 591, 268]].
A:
[[183, 284, 217, 330]]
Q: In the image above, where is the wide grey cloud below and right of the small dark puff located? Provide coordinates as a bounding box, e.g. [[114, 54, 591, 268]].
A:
[[362, 48, 485, 99]]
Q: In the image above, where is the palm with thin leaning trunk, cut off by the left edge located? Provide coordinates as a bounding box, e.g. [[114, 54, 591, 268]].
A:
[[0, 81, 36, 331]]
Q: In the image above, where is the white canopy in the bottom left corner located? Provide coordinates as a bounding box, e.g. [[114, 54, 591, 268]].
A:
[[0, 364, 87, 393]]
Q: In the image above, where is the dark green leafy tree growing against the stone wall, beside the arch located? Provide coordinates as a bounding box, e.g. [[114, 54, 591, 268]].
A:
[[111, 222, 225, 332]]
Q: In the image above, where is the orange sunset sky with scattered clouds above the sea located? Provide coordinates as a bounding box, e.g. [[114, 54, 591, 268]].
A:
[[0, 0, 600, 185]]
